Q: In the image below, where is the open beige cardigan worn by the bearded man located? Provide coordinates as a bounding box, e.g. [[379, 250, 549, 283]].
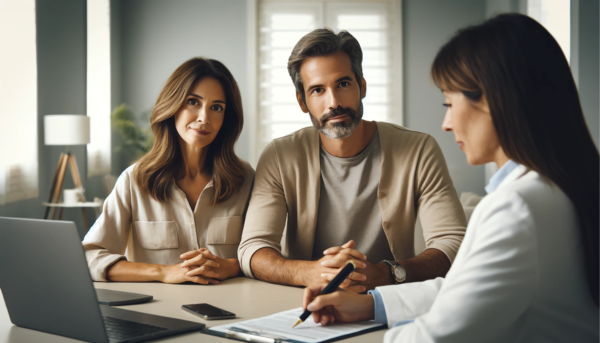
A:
[[238, 122, 467, 277]]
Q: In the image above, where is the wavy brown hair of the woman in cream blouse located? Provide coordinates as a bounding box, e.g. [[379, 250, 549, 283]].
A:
[[133, 58, 246, 205]]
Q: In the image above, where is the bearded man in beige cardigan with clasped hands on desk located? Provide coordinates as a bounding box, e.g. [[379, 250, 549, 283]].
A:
[[238, 29, 466, 292]]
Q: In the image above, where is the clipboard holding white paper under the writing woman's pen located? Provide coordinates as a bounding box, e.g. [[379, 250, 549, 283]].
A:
[[201, 308, 386, 343]]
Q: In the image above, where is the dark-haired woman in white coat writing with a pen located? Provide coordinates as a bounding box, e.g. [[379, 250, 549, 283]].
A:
[[304, 14, 599, 342]]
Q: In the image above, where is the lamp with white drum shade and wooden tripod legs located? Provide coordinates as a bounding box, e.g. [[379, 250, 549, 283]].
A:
[[44, 114, 90, 223]]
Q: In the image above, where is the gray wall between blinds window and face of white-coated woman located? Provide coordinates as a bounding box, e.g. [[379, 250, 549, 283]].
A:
[[402, 0, 486, 195]]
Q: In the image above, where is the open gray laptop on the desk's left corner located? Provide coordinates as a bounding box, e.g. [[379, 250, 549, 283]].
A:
[[0, 217, 205, 342]]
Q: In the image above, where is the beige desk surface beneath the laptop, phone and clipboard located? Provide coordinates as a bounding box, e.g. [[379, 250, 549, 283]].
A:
[[0, 277, 385, 343]]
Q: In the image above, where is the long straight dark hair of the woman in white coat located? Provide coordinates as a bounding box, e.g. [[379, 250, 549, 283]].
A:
[[431, 14, 600, 305]]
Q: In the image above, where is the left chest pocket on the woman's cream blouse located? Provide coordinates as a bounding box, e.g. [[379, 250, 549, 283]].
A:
[[133, 221, 179, 250]]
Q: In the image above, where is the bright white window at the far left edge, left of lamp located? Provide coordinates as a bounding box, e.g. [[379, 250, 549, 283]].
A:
[[0, 0, 39, 205]]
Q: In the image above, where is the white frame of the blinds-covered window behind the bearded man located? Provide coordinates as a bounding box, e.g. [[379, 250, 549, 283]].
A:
[[245, 0, 404, 167]]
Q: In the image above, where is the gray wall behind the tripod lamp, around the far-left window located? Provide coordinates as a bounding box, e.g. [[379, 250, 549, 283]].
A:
[[0, 0, 103, 239]]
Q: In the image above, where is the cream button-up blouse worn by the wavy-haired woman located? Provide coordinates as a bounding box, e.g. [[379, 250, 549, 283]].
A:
[[83, 163, 254, 281]]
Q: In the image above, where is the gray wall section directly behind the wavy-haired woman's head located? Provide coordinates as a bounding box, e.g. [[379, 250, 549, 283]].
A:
[[111, 0, 251, 170]]
